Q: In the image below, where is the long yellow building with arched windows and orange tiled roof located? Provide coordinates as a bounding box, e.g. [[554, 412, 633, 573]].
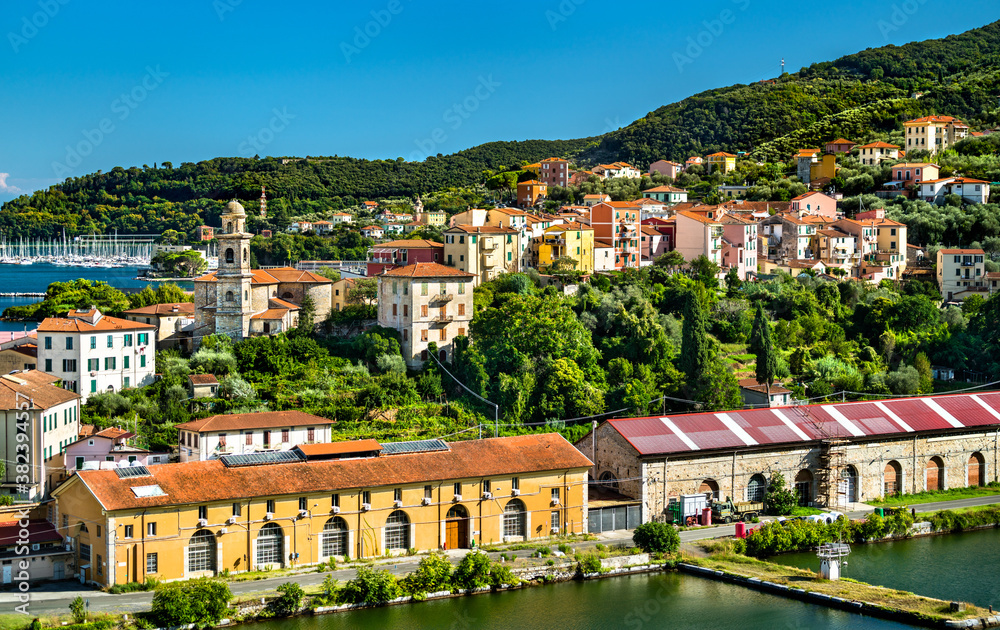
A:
[[54, 434, 591, 586]]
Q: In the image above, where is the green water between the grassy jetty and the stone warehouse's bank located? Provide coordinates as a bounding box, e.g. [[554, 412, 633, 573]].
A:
[[771, 529, 1000, 608]]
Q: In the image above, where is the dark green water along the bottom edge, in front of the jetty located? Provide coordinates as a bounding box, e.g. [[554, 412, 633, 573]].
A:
[[245, 573, 908, 630]]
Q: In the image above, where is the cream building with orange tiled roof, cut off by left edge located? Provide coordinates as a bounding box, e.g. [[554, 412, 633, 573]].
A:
[[0, 370, 80, 500]]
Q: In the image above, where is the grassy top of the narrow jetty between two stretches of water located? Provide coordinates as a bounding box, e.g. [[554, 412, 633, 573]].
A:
[[688, 553, 987, 620]]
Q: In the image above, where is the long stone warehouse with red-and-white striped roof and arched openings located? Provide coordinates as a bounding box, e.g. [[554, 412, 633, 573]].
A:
[[576, 392, 1000, 531]]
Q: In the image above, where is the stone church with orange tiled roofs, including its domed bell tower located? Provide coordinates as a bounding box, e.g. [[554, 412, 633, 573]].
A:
[[194, 201, 333, 339]]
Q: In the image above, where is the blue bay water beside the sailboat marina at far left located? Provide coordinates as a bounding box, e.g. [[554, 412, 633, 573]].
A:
[[0, 263, 193, 330]]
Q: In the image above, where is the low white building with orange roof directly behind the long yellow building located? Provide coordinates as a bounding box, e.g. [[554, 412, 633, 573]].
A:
[[177, 411, 333, 463]]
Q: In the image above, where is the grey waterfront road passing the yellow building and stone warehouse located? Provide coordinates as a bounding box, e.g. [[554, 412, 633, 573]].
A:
[[0, 495, 1000, 615]]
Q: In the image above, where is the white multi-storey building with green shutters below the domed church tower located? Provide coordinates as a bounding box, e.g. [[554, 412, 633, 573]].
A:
[[37, 308, 156, 402]]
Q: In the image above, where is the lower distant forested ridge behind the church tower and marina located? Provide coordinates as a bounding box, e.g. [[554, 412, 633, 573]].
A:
[[0, 138, 599, 238]]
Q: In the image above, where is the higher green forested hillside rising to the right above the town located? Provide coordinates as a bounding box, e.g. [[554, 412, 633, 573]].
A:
[[581, 22, 1000, 165]]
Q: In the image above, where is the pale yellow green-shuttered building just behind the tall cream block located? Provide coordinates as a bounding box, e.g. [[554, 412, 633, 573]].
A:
[[444, 225, 522, 285]]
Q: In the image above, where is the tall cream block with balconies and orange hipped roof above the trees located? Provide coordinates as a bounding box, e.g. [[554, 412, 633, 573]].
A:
[[378, 263, 478, 368]]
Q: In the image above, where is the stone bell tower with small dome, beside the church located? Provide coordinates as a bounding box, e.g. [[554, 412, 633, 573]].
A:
[[215, 199, 253, 339]]
